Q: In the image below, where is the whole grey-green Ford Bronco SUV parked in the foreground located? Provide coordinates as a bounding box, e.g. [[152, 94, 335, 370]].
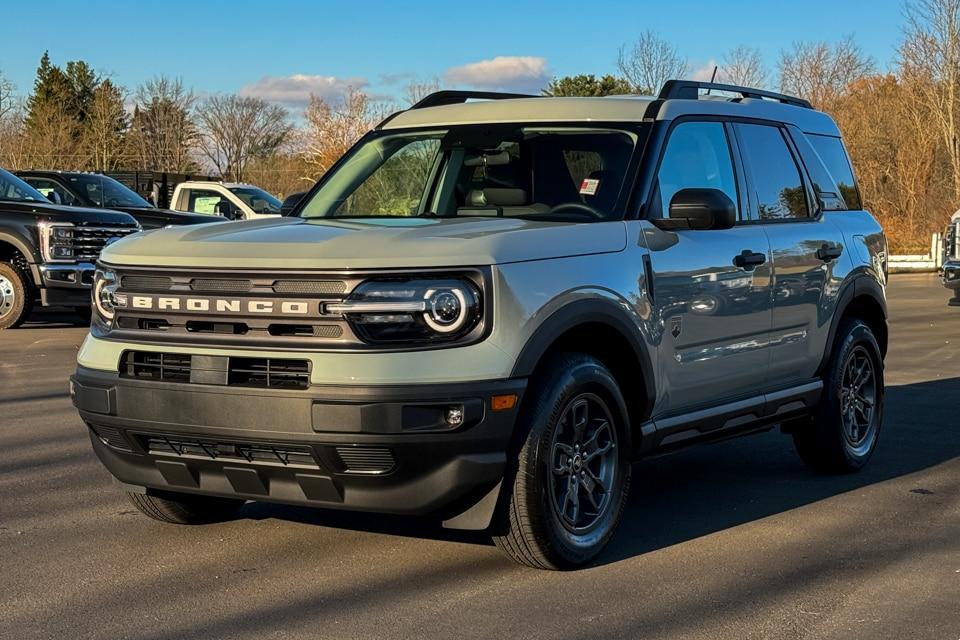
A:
[[72, 81, 887, 568]]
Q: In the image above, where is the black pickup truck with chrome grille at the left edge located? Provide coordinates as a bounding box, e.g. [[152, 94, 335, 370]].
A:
[[0, 169, 140, 329]]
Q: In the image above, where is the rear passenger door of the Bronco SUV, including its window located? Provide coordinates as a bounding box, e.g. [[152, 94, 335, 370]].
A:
[[735, 124, 843, 387]]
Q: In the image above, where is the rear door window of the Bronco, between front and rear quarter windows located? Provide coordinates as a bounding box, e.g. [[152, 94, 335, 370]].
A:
[[737, 124, 810, 221]]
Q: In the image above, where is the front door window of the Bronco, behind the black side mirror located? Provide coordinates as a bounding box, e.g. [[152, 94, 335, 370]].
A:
[[651, 122, 737, 218]]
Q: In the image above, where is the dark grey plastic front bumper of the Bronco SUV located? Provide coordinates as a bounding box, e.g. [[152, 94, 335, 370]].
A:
[[71, 367, 526, 519]]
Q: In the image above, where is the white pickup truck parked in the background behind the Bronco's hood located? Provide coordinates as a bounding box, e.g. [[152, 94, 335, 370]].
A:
[[170, 181, 281, 220]]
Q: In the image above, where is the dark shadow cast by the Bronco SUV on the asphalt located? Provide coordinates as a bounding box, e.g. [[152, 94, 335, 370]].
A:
[[231, 378, 960, 565]]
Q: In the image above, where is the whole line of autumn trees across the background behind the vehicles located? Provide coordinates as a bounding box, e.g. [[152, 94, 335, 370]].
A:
[[0, 0, 960, 252]]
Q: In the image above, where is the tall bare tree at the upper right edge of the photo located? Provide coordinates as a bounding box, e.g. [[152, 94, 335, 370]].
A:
[[899, 0, 960, 200]]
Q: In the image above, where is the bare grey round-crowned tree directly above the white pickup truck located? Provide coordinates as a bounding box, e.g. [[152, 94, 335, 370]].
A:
[[196, 95, 291, 182]]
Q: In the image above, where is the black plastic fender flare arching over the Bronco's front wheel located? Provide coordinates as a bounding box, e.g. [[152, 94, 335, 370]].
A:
[[511, 299, 656, 426]]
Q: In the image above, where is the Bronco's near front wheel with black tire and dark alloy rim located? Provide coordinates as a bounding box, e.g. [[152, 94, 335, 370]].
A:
[[493, 354, 630, 569]]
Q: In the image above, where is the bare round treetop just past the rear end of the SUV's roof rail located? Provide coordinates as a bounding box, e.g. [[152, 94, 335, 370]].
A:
[[778, 36, 874, 108]]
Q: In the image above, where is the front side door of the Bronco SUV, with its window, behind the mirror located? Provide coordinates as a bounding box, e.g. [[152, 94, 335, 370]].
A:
[[644, 120, 771, 414]]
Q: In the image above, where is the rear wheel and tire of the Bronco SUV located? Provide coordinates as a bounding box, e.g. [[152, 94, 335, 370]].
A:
[[793, 318, 884, 473]]
